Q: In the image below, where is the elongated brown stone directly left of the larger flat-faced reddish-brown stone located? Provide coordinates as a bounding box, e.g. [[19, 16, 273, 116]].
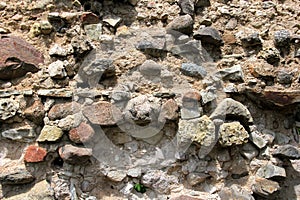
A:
[[48, 102, 80, 120]]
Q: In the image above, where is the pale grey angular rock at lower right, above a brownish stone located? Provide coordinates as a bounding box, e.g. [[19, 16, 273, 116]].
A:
[[256, 164, 286, 178]]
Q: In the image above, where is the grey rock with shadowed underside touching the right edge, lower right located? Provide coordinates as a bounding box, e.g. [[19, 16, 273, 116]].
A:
[[273, 144, 300, 159]]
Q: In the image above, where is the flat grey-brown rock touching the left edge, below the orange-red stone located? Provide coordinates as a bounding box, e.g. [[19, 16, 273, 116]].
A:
[[0, 168, 35, 185]]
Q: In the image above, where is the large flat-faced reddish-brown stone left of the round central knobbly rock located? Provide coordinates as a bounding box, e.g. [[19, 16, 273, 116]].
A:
[[83, 101, 116, 125]]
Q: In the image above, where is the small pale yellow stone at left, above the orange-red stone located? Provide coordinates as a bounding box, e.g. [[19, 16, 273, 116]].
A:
[[37, 125, 63, 142]]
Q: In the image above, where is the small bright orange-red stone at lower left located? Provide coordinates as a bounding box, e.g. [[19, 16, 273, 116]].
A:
[[24, 145, 47, 162]]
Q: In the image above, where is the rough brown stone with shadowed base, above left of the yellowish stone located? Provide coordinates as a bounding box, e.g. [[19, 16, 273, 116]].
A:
[[24, 100, 45, 124]]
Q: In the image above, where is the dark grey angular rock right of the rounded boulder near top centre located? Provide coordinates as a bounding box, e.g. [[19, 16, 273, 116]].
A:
[[194, 27, 224, 46]]
